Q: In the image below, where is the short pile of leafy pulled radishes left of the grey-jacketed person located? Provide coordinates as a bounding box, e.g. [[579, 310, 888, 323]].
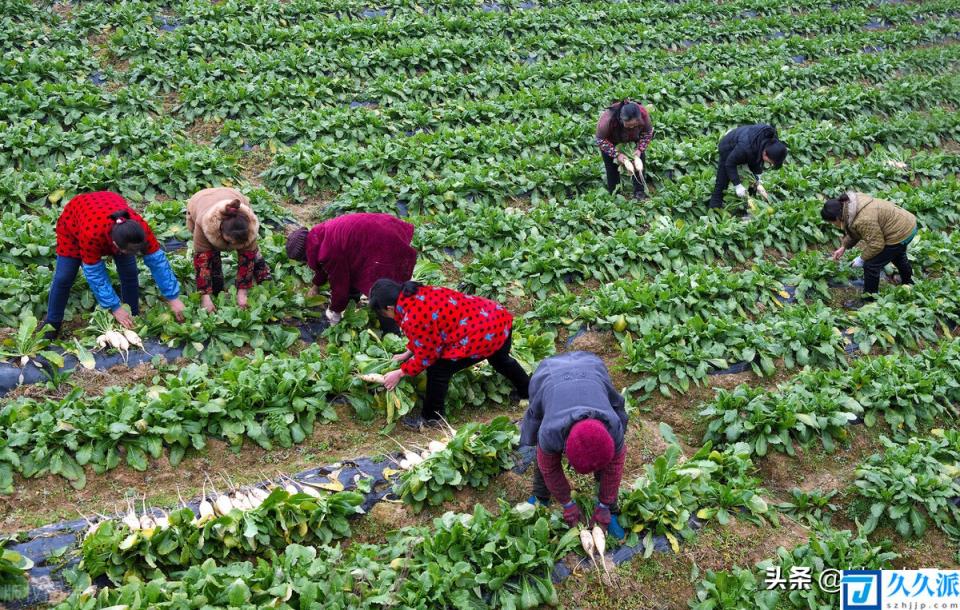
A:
[[394, 417, 520, 512]]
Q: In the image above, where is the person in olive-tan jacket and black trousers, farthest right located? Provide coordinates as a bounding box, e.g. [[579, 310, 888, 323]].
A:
[[820, 191, 917, 298]]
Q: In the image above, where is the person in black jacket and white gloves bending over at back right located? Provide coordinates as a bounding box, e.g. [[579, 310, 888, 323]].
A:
[[708, 123, 787, 208]]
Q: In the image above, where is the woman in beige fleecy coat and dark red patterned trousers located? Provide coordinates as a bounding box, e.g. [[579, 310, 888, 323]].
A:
[[187, 187, 270, 313]]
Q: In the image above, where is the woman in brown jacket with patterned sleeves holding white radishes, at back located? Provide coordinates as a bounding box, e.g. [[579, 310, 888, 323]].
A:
[[596, 100, 653, 199]]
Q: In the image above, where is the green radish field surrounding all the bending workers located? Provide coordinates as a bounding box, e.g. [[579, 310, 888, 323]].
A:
[[0, 0, 960, 610]]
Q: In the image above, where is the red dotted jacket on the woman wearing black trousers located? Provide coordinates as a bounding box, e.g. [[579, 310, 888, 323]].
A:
[[394, 286, 513, 376]]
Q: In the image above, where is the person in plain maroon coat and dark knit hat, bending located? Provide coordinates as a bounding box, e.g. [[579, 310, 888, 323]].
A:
[[287, 213, 417, 335]]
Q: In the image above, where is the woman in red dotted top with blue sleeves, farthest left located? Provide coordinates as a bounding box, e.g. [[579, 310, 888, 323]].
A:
[[46, 191, 184, 332]]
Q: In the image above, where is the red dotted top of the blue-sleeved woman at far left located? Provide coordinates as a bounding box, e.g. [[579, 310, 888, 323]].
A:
[[57, 191, 160, 265]]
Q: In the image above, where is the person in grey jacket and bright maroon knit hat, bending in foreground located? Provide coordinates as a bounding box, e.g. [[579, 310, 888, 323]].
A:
[[520, 352, 627, 538]]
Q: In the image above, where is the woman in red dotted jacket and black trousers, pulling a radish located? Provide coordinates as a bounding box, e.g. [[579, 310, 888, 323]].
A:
[[370, 279, 530, 429]]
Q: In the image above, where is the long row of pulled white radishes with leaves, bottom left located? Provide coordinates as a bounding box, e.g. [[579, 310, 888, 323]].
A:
[[80, 486, 363, 583]]
